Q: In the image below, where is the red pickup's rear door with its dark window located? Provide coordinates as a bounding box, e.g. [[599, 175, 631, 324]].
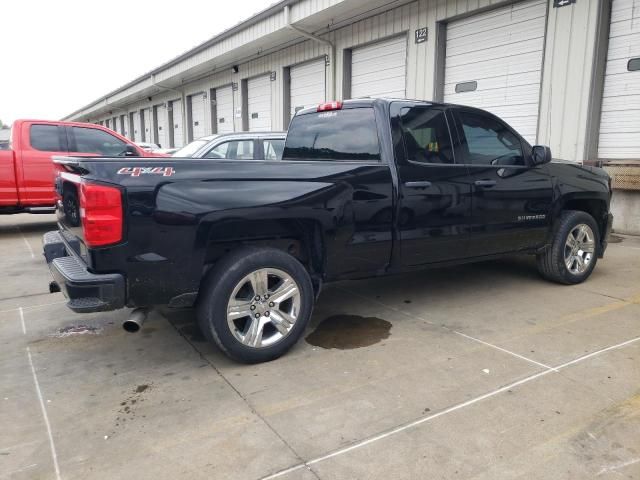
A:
[[16, 123, 69, 205]]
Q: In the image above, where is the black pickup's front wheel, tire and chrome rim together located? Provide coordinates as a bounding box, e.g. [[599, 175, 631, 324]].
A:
[[537, 210, 600, 285]]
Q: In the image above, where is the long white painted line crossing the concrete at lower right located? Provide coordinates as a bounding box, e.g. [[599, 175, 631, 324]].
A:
[[260, 337, 640, 480]]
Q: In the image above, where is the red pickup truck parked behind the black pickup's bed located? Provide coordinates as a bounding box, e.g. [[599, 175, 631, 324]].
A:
[[0, 120, 166, 214]]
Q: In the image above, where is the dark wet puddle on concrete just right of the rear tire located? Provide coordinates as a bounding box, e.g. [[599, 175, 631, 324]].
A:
[[305, 315, 391, 350]]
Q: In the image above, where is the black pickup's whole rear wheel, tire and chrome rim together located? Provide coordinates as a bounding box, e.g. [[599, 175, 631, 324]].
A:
[[197, 247, 314, 363]]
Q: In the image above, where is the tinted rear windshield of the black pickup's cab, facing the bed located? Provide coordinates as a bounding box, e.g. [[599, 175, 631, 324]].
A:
[[282, 108, 380, 162]]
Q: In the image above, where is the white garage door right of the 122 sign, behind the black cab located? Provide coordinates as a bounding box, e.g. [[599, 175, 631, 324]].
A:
[[444, 0, 547, 143]]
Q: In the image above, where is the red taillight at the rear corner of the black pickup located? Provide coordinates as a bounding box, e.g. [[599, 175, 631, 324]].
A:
[[80, 182, 122, 247]]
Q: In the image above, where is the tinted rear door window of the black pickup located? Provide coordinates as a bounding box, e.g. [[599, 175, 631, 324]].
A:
[[400, 107, 454, 163]]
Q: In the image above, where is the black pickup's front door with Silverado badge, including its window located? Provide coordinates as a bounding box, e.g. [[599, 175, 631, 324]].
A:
[[453, 108, 553, 256]]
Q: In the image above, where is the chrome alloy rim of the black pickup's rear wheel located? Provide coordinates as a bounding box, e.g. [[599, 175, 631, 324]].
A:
[[227, 268, 300, 348]]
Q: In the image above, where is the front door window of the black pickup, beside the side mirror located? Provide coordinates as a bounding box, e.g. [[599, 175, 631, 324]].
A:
[[458, 112, 525, 165]]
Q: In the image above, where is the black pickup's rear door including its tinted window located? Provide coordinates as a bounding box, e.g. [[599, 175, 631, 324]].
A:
[[392, 104, 471, 267]]
